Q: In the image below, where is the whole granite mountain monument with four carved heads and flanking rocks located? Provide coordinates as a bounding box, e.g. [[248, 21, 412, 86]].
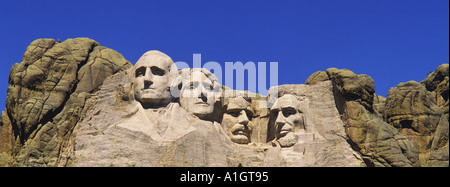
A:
[[0, 38, 449, 167]]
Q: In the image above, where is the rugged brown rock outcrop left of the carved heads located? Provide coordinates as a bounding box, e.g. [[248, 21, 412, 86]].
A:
[[0, 38, 132, 166]]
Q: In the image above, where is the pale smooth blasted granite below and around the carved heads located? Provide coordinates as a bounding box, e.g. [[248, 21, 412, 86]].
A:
[[69, 72, 362, 167]]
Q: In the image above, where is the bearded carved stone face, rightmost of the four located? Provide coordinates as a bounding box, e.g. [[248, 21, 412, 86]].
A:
[[270, 94, 305, 147]]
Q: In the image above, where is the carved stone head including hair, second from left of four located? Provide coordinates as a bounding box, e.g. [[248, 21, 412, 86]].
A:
[[174, 68, 221, 121]]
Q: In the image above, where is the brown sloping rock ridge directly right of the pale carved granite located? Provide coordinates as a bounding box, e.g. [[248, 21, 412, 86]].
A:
[[307, 68, 420, 167]]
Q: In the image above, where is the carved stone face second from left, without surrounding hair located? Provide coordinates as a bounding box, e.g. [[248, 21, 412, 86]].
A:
[[180, 69, 218, 119]]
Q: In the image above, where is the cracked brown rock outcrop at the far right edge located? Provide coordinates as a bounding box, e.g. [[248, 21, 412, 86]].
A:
[[383, 64, 449, 166]]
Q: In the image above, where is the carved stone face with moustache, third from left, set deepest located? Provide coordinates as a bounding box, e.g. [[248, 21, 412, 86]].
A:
[[222, 97, 252, 144]]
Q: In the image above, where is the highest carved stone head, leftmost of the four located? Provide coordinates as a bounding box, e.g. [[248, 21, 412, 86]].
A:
[[132, 51, 174, 105]]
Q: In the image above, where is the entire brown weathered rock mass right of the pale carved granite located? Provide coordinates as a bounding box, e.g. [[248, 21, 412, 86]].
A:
[[306, 64, 449, 166]]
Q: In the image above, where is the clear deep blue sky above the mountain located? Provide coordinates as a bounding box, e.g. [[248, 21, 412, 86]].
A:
[[0, 0, 449, 110]]
